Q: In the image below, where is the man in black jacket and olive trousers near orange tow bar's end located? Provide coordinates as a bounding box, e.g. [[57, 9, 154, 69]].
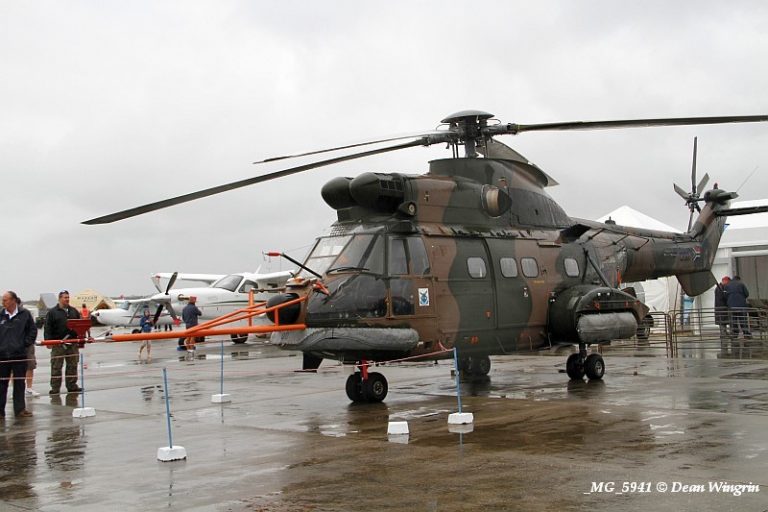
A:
[[43, 290, 82, 395]]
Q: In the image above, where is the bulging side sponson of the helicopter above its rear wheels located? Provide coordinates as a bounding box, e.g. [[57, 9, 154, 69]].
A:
[[549, 285, 648, 344]]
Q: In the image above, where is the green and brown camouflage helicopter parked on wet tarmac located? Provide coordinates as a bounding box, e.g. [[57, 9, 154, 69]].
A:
[[84, 110, 768, 402]]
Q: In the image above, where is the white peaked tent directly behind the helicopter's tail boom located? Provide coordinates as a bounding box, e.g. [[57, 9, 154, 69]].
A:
[[597, 205, 682, 313]]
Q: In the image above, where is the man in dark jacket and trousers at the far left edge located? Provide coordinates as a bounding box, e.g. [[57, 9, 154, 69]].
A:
[[0, 290, 37, 418]]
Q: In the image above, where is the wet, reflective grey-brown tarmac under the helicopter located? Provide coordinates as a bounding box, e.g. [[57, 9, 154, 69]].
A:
[[0, 332, 768, 511]]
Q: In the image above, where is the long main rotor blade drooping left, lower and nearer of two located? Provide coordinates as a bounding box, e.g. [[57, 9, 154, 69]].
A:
[[82, 137, 435, 225]]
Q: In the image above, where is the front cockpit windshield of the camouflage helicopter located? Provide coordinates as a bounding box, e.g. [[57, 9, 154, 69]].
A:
[[302, 235, 384, 274]]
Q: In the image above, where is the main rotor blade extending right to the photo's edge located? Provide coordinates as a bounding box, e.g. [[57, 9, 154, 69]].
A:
[[506, 115, 768, 134]]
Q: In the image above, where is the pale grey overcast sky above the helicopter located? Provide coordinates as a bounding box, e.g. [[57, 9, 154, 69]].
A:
[[0, 0, 768, 299]]
